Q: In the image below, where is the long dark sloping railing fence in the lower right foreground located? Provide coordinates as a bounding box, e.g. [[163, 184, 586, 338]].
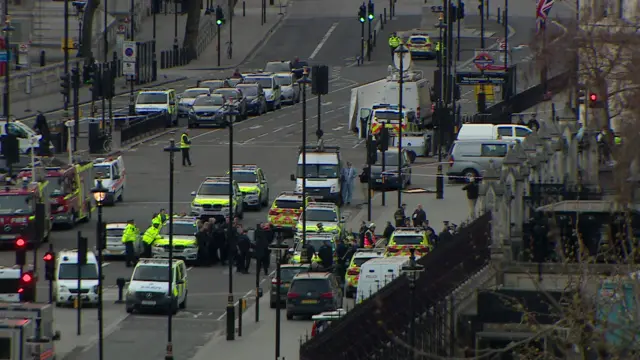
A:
[[300, 213, 491, 360]]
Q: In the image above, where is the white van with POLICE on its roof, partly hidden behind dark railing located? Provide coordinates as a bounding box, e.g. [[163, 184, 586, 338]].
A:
[[356, 256, 409, 304]]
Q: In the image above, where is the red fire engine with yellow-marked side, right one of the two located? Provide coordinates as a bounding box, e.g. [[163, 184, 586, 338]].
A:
[[19, 161, 94, 228]]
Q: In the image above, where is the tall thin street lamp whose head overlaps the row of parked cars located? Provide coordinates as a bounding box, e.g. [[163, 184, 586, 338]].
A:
[[224, 105, 240, 340]]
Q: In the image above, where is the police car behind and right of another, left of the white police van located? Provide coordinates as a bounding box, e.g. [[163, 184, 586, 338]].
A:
[[232, 164, 269, 210]]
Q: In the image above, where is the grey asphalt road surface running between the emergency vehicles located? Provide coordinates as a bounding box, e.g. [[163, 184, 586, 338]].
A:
[[0, 4, 510, 360]]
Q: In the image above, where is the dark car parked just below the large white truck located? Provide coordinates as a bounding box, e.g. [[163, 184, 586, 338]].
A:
[[371, 148, 411, 190]]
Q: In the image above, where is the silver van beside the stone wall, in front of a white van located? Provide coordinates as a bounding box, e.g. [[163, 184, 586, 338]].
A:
[[447, 140, 517, 182]]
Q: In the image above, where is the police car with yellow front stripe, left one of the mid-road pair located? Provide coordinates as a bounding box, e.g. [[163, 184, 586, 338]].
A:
[[191, 176, 244, 219]]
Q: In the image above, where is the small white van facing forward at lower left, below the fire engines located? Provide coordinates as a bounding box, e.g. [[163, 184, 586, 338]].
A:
[[53, 250, 98, 306]]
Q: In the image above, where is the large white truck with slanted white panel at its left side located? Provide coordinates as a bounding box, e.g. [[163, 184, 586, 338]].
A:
[[347, 67, 433, 138]]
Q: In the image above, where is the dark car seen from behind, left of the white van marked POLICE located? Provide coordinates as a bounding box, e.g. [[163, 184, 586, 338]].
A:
[[287, 272, 342, 320]]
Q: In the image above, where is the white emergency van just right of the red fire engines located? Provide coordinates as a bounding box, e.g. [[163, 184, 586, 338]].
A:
[[93, 155, 127, 204]]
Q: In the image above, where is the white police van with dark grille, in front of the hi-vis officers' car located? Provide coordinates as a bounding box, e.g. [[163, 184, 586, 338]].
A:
[[126, 259, 188, 314]]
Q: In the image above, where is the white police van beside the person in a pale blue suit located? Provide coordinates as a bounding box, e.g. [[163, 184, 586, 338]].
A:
[[291, 142, 342, 205]]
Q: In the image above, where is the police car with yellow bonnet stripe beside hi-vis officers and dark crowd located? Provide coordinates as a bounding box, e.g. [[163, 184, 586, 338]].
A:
[[151, 216, 198, 261]]
